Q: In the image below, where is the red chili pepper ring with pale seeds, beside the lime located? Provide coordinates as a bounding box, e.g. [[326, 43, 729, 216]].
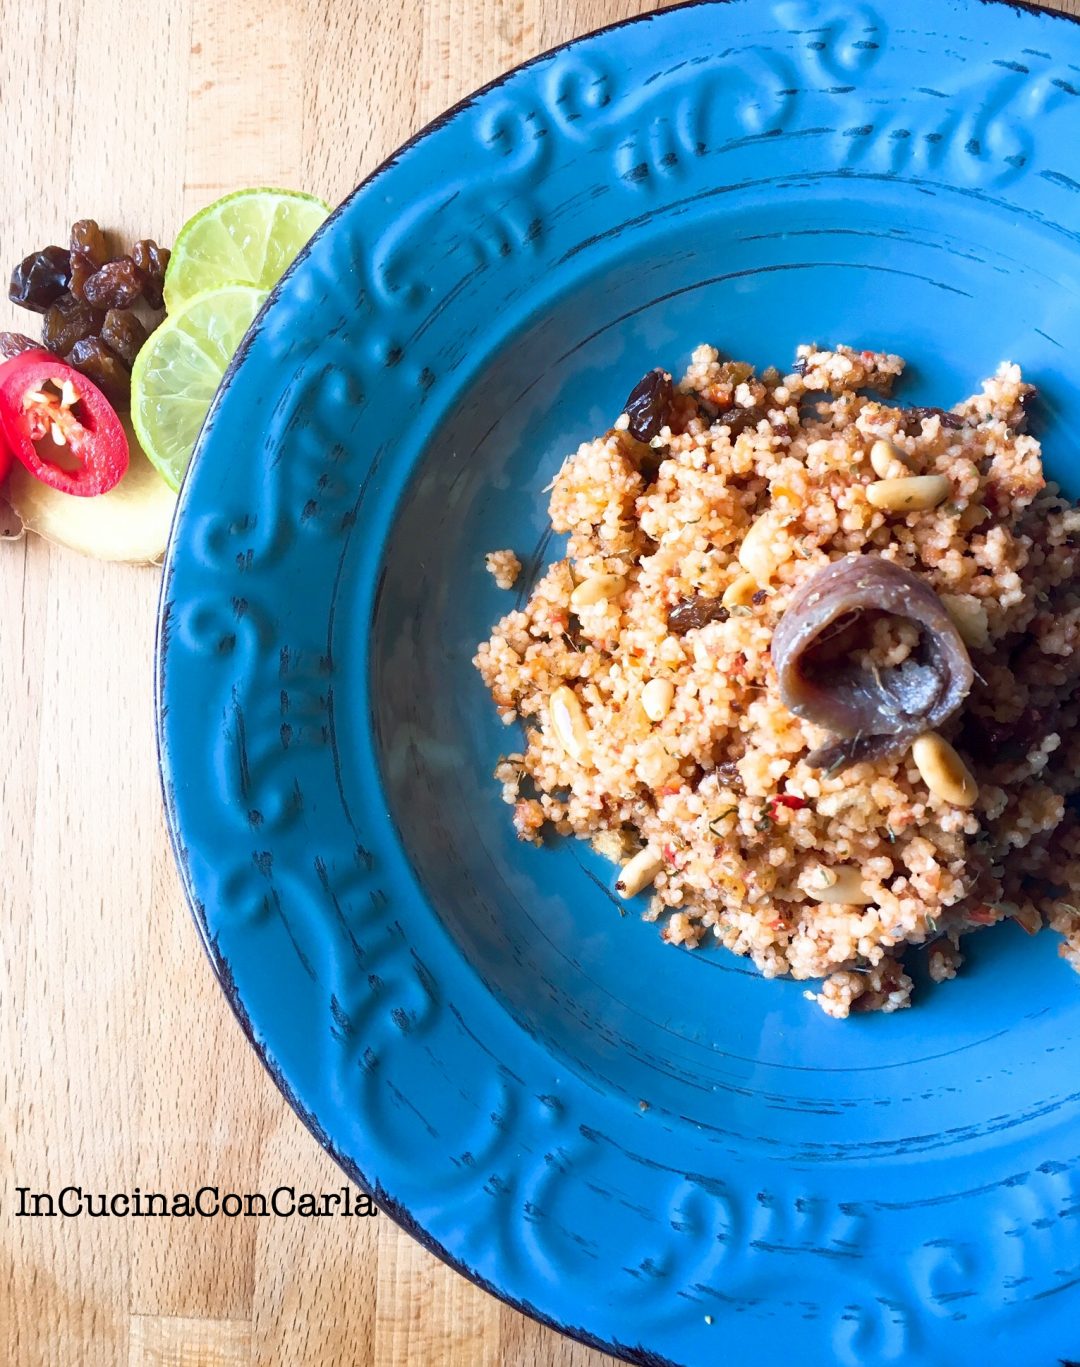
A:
[[0, 351, 127, 498]]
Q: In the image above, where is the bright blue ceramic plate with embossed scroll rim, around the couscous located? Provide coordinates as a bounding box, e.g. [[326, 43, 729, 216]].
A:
[[160, 0, 1080, 1367]]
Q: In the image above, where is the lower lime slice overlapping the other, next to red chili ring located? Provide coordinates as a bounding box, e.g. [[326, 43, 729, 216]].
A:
[[131, 284, 267, 489]]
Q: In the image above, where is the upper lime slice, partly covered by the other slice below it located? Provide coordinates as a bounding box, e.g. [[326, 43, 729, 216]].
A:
[[165, 190, 329, 313]]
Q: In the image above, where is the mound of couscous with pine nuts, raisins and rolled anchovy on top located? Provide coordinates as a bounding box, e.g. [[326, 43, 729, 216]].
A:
[[476, 346, 1080, 1017]]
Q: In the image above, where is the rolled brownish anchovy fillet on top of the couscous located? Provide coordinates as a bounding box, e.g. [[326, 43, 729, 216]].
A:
[[772, 555, 973, 770]]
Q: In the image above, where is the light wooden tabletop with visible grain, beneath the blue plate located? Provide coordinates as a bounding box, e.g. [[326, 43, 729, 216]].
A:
[[0, 0, 1080, 1367]]
